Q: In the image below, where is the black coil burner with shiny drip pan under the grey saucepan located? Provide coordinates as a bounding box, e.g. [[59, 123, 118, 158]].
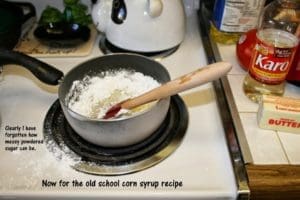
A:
[[44, 95, 188, 175]]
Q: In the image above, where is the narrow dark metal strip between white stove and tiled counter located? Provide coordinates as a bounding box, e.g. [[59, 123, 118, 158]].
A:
[[198, 3, 251, 199]]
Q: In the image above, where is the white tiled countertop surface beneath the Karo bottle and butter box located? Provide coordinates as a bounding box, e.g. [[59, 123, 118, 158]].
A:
[[218, 44, 300, 165]]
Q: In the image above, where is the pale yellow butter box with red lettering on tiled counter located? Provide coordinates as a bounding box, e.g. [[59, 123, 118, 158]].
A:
[[257, 95, 300, 133]]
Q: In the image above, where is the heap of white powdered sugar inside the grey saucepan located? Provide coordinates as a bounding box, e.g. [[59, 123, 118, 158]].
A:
[[66, 69, 160, 119]]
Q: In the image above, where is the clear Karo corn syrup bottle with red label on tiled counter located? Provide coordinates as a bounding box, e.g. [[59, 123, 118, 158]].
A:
[[243, 0, 300, 102]]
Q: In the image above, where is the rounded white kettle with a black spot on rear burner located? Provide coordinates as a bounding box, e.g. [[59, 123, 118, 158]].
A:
[[92, 0, 185, 52]]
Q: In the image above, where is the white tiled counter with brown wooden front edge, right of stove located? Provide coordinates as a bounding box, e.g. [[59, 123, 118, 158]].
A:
[[199, 3, 300, 199]]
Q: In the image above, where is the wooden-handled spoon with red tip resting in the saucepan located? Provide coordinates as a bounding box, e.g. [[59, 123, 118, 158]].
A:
[[103, 62, 232, 119]]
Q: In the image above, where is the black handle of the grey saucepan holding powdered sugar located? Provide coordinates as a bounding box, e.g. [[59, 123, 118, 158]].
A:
[[0, 49, 64, 85]]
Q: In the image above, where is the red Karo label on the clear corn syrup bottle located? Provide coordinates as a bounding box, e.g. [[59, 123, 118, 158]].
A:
[[249, 36, 296, 85]]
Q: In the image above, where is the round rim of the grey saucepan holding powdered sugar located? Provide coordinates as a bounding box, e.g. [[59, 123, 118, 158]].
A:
[[58, 52, 171, 123]]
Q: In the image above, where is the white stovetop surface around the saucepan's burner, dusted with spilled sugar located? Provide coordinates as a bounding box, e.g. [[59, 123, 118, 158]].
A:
[[0, 8, 238, 199]]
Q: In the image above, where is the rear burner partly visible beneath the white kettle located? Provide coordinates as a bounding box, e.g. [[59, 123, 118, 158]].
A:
[[99, 36, 179, 58]]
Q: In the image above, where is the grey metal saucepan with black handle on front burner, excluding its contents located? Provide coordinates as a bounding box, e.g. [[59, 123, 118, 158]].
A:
[[0, 49, 170, 147]]
